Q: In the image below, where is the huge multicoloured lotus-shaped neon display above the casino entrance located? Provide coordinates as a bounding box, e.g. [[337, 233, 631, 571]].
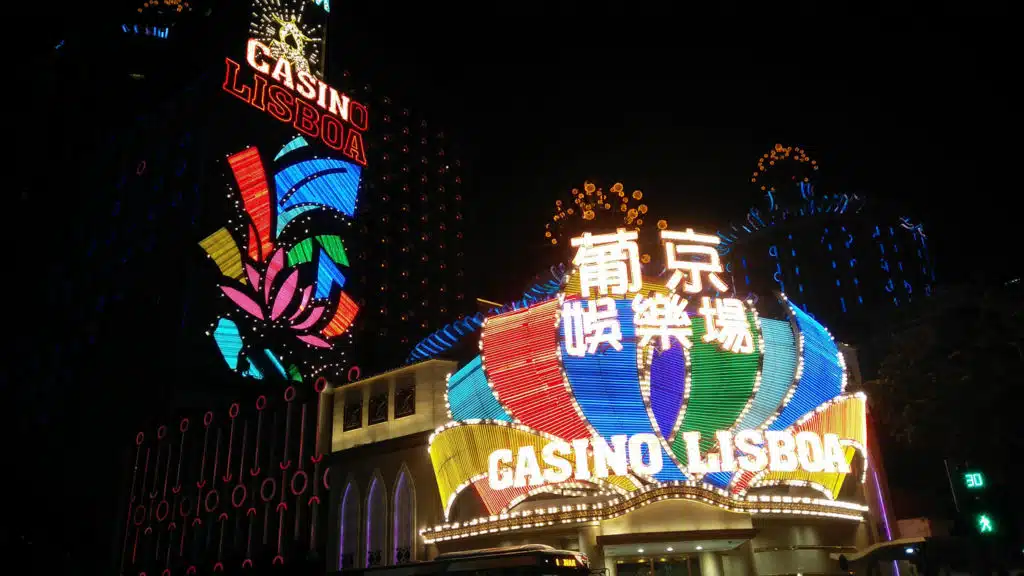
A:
[[430, 231, 866, 517]]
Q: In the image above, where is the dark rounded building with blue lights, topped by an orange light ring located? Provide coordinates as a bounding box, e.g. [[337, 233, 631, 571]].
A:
[[718, 145, 935, 341]]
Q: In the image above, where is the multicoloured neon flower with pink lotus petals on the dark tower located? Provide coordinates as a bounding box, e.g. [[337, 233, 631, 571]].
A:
[[200, 136, 360, 379]]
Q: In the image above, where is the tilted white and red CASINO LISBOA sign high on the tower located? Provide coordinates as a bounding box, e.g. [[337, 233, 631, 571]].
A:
[[223, 39, 370, 166]]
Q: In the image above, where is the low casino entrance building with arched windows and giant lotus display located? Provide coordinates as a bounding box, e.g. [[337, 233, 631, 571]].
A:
[[327, 230, 894, 576]]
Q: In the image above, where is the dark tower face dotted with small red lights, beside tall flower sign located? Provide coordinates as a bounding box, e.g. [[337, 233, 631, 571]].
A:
[[345, 76, 475, 371]]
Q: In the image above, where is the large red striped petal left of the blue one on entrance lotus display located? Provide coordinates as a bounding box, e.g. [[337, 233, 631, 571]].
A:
[[480, 299, 591, 441]]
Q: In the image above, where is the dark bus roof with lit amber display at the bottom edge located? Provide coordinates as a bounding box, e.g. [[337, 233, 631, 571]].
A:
[[337, 544, 590, 576]]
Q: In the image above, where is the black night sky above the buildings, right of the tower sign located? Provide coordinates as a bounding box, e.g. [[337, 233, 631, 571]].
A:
[[329, 2, 1019, 297]]
